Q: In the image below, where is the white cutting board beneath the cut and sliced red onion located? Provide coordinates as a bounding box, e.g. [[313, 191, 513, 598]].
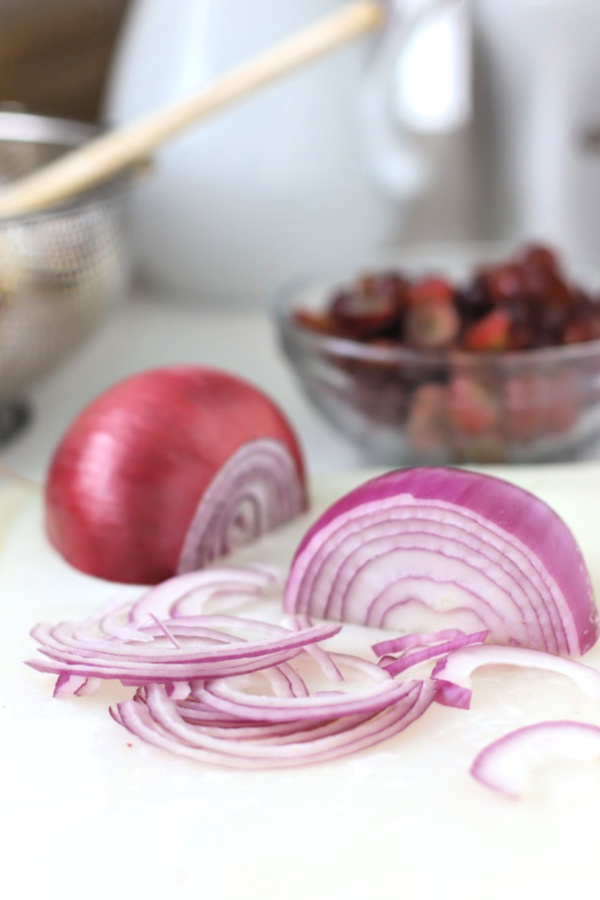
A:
[[0, 472, 600, 900]]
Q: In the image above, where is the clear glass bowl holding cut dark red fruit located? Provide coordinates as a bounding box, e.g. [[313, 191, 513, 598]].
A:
[[275, 244, 600, 465]]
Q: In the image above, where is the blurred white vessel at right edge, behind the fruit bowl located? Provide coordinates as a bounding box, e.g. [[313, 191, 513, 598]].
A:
[[475, 0, 600, 260]]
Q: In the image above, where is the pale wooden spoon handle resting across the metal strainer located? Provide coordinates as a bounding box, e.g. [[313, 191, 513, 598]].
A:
[[0, 0, 385, 216]]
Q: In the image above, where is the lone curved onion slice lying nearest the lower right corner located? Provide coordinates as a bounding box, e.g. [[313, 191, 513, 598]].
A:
[[471, 721, 600, 800]]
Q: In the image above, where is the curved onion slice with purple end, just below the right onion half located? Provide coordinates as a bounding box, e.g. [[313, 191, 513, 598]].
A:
[[432, 644, 600, 706]]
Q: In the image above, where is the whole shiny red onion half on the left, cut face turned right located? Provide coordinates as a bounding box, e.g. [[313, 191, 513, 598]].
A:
[[46, 366, 307, 584]]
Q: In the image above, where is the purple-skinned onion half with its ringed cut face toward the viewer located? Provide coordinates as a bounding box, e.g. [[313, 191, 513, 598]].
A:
[[285, 468, 598, 654]]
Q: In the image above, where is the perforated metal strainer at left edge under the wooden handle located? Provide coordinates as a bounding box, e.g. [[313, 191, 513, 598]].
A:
[[0, 112, 132, 440]]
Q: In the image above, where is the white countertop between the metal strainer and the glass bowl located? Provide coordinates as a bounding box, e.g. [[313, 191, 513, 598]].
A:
[[0, 293, 364, 480]]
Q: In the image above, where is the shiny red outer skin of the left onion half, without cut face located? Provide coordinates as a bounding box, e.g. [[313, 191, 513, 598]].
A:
[[45, 366, 307, 584]]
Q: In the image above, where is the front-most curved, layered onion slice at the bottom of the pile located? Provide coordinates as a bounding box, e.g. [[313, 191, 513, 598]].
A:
[[111, 668, 435, 769]]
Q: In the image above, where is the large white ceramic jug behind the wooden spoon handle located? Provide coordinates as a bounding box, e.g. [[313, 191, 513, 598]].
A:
[[106, 0, 454, 302]]
